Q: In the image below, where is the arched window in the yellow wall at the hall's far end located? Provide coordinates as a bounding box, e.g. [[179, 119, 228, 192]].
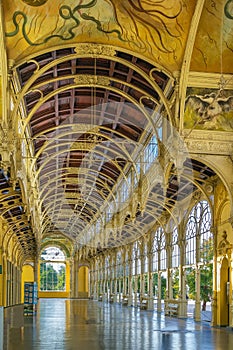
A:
[[40, 247, 66, 291]]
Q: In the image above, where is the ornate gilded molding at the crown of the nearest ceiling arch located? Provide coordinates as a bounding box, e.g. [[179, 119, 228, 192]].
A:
[[74, 43, 116, 57]]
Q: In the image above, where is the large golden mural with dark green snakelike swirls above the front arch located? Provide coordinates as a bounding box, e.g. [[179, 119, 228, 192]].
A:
[[4, 0, 195, 68]]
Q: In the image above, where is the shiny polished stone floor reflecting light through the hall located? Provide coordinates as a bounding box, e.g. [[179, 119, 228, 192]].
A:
[[9, 299, 233, 350]]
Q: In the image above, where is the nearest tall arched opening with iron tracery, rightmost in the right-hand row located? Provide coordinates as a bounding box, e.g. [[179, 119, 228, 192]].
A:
[[185, 200, 213, 320]]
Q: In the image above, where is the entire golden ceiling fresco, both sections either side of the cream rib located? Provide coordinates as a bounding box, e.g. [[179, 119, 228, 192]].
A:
[[3, 0, 233, 72]]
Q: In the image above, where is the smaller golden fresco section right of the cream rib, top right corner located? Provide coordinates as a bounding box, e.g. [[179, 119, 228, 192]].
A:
[[190, 0, 233, 73]]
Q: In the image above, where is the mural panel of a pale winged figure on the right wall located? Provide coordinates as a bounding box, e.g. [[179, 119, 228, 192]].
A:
[[184, 88, 233, 131]]
